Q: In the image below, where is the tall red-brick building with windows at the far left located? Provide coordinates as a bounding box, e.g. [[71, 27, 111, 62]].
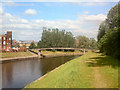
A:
[[0, 31, 12, 51]]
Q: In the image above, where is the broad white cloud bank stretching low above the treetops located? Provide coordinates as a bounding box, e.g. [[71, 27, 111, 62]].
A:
[[2, 7, 106, 41]]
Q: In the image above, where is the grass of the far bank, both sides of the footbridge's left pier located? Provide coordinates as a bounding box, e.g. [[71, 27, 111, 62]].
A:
[[0, 50, 82, 58]]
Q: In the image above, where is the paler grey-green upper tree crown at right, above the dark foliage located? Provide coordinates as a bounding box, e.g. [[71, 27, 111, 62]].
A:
[[97, 3, 120, 41]]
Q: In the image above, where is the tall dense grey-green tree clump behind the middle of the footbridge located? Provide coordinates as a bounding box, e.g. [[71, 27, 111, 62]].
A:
[[37, 28, 75, 48]]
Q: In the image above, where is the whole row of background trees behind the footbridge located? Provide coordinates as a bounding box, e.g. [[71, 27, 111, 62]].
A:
[[29, 27, 97, 49]]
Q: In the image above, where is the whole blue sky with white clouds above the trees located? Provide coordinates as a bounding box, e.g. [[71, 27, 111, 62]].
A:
[[0, 2, 117, 41]]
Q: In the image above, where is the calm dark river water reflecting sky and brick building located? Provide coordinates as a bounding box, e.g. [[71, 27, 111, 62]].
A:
[[2, 56, 78, 88]]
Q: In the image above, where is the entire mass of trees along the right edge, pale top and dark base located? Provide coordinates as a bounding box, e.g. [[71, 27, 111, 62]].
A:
[[97, 3, 120, 59]]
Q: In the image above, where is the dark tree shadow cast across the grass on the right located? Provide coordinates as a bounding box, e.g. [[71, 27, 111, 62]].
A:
[[87, 55, 120, 68]]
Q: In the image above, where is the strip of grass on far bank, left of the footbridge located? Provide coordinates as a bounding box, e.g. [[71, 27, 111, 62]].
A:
[[0, 52, 32, 58]]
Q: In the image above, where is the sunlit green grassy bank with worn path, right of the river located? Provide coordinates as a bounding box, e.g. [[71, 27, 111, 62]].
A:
[[25, 52, 118, 88]]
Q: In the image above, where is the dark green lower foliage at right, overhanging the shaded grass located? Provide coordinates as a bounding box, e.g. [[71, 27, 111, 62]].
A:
[[98, 28, 120, 58]]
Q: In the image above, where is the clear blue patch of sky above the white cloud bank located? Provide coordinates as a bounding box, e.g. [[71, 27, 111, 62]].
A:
[[3, 2, 116, 20]]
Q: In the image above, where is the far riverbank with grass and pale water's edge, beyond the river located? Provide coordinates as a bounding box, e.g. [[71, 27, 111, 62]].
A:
[[0, 51, 83, 63]]
